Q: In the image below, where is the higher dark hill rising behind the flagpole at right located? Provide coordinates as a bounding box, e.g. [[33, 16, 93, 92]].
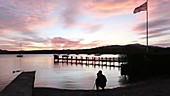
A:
[[81, 44, 169, 54]]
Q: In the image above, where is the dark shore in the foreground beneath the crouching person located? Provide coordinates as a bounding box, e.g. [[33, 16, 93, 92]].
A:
[[34, 77, 170, 96]]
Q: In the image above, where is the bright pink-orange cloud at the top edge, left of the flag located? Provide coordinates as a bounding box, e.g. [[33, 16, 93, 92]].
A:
[[83, 0, 146, 17]]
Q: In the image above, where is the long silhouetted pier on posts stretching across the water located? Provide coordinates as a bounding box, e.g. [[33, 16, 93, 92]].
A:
[[54, 55, 125, 67]]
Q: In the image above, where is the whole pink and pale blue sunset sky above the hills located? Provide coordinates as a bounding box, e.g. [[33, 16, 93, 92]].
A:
[[0, 0, 170, 51]]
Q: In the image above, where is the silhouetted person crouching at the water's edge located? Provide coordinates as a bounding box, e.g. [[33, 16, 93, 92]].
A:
[[96, 70, 107, 90]]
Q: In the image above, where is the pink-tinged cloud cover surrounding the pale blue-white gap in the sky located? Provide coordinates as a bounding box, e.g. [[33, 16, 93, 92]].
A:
[[0, 0, 170, 50]]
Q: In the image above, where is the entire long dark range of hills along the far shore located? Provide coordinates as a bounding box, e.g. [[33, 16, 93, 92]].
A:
[[0, 44, 170, 54]]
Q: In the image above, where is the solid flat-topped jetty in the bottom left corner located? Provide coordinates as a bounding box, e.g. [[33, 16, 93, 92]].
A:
[[0, 71, 35, 96]]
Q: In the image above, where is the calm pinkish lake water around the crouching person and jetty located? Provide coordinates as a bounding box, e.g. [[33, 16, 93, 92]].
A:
[[0, 54, 123, 91]]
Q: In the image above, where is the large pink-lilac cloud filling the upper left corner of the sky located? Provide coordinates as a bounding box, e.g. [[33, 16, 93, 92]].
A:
[[0, 0, 56, 33]]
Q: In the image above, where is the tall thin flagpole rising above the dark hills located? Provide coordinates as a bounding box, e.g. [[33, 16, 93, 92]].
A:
[[146, 0, 149, 53]]
